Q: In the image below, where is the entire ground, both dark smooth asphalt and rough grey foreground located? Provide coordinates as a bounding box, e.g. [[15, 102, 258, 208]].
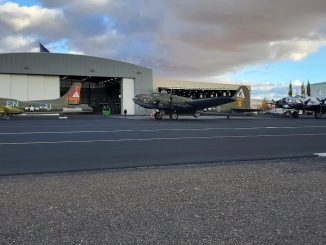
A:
[[0, 116, 326, 244]]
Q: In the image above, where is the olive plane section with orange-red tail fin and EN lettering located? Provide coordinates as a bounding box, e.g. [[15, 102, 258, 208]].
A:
[[0, 82, 93, 119]]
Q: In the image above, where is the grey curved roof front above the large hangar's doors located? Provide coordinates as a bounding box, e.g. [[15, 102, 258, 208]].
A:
[[0, 53, 153, 79]]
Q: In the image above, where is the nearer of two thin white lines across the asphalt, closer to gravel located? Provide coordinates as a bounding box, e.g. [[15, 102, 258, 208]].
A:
[[0, 133, 326, 145]]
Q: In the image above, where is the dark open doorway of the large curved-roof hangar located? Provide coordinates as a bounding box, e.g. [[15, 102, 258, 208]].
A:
[[60, 76, 122, 114]]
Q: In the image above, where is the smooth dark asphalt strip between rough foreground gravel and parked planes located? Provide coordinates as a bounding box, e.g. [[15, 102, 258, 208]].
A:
[[0, 116, 326, 175]]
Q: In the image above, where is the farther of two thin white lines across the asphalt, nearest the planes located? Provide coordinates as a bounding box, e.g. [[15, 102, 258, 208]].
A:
[[0, 126, 326, 135]]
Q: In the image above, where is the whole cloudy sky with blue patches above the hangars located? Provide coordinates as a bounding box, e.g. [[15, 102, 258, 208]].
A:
[[0, 0, 326, 99]]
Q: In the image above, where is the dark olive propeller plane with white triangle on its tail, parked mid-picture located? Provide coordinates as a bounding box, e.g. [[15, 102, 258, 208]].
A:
[[133, 86, 249, 120]]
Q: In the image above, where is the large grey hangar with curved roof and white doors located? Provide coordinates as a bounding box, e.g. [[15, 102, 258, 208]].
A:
[[0, 53, 153, 115]]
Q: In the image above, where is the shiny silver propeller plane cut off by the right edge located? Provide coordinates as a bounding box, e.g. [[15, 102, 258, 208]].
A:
[[270, 95, 326, 118]]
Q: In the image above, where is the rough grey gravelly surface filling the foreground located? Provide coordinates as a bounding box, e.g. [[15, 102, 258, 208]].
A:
[[0, 157, 326, 244]]
